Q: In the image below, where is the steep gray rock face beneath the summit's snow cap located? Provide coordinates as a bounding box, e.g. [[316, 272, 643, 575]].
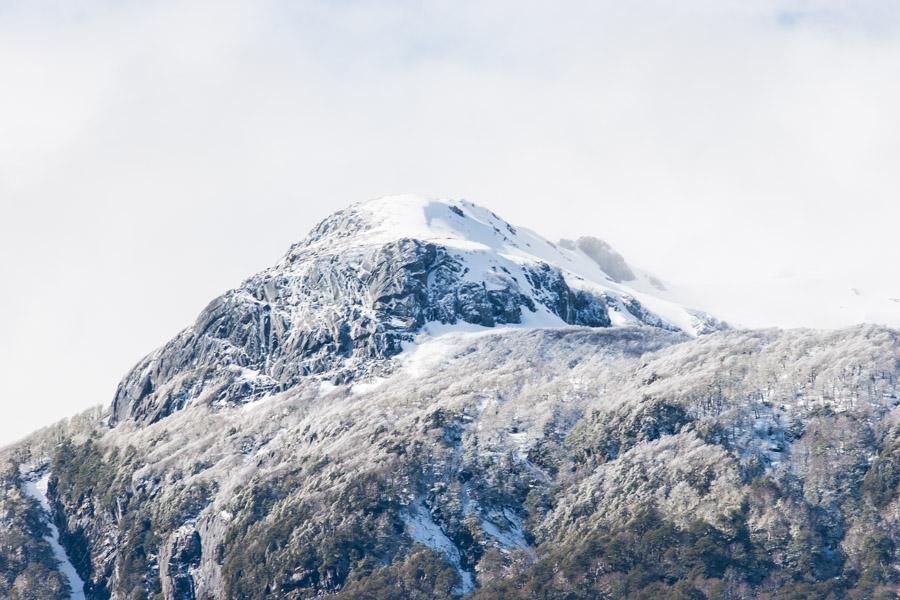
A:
[[112, 255, 661, 422]]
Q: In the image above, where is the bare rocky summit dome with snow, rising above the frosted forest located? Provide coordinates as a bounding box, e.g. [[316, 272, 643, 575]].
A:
[[112, 196, 724, 422]]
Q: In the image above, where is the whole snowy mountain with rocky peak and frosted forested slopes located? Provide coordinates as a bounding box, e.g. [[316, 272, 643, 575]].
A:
[[0, 196, 900, 600]]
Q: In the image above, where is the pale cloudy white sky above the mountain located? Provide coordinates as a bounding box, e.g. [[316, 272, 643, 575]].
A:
[[0, 0, 900, 444]]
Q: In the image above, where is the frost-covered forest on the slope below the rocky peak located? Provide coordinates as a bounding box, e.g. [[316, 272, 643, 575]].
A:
[[0, 327, 900, 599]]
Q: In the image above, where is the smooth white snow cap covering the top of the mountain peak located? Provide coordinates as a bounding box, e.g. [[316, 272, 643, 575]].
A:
[[304, 194, 724, 336]]
